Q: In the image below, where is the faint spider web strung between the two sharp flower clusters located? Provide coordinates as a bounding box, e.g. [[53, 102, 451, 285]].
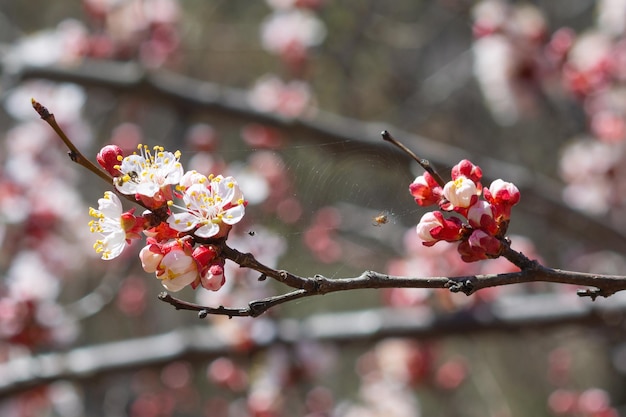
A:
[[207, 133, 421, 277]]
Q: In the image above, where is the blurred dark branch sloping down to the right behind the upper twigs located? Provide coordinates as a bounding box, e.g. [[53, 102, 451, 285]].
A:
[[6, 60, 626, 252]]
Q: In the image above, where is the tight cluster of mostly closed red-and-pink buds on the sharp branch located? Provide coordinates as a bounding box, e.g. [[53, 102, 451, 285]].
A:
[[409, 159, 520, 262]]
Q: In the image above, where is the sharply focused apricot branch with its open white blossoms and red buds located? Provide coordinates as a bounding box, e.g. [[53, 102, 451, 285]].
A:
[[32, 100, 626, 318]]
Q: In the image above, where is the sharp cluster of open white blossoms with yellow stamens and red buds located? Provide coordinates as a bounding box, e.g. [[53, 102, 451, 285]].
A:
[[89, 145, 246, 291]]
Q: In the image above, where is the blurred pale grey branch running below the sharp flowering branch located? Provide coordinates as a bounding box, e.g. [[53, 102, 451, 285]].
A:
[[0, 293, 626, 397]]
